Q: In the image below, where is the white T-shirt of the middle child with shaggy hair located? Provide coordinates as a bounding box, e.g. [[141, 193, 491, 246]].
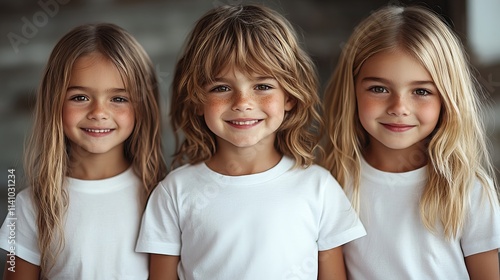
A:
[[136, 157, 366, 280]]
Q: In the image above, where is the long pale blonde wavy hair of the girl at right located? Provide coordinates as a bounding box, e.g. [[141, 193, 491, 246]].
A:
[[322, 6, 498, 238]]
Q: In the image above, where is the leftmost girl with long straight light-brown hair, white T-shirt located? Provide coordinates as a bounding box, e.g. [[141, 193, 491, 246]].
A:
[[0, 23, 166, 280]]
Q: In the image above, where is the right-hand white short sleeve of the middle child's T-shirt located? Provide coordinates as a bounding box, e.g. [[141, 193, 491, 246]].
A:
[[318, 175, 366, 251]]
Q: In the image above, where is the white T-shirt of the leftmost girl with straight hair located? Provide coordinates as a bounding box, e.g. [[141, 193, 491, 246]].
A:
[[0, 169, 149, 280]]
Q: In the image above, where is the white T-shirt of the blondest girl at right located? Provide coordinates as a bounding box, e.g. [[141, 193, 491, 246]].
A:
[[344, 160, 500, 280]]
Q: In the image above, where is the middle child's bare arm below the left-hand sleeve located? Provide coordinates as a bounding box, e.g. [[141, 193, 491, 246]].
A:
[[149, 254, 179, 280]]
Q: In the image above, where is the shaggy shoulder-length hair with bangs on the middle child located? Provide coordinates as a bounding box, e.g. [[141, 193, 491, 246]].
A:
[[170, 5, 322, 166]]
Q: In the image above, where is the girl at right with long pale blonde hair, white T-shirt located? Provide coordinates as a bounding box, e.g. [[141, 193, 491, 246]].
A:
[[323, 6, 500, 279]]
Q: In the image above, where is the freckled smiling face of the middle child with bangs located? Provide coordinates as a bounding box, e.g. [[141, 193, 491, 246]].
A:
[[202, 68, 295, 153]]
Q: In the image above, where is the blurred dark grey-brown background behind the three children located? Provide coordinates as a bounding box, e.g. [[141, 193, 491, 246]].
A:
[[0, 0, 500, 274]]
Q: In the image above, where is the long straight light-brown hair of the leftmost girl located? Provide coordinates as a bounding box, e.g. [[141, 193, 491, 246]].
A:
[[25, 23, 166, 277]]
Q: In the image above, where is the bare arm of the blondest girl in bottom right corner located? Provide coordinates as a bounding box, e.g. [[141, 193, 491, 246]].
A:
[[465, 249, 500, 280]]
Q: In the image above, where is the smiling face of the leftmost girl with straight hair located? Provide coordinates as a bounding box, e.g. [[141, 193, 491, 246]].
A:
[[62, 53, 135, 161]]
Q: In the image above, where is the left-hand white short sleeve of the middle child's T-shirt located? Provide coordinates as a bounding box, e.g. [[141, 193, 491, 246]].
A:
[[136, 182, 181, 256]]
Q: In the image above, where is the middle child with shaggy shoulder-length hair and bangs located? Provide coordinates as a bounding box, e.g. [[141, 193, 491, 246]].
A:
[[136, 5, 365, 279]]
